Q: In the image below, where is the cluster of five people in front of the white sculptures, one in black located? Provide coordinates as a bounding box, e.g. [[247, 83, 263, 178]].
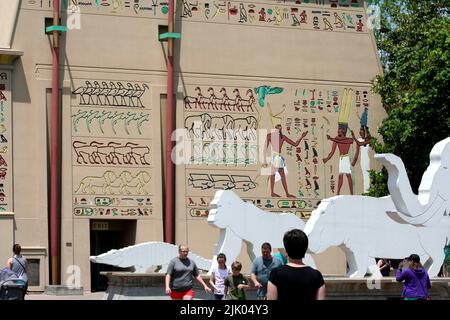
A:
[[165, 229, 325, 301]]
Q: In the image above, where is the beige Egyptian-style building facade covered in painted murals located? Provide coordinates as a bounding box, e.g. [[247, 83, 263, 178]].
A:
[[0, 0, 385, 290]]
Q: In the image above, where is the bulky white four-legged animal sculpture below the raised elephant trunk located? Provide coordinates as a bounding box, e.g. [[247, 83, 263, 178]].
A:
[[304, 196, 450, 278]]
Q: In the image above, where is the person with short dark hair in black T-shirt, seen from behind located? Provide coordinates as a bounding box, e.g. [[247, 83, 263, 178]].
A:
[[267, 229, 325, 301]]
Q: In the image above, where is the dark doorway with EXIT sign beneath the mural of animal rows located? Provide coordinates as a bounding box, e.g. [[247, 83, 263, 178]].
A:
[[90, 220, 136, 292]]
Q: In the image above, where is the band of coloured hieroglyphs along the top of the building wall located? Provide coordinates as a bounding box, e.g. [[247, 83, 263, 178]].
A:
[[24, 0, 367, 32]]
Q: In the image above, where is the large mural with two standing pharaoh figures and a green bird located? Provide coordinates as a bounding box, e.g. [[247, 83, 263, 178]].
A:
[[179, 83, 371, 218]]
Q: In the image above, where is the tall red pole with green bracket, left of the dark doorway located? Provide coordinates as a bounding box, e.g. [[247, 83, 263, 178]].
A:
[[50, 0, 60, 285]]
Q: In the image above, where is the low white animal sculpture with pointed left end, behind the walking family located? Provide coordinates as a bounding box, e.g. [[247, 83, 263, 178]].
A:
[[90, 242, 211, 273]]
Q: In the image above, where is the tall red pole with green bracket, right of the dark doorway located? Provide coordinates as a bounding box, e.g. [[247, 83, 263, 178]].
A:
[[164, 0, 175, 243]]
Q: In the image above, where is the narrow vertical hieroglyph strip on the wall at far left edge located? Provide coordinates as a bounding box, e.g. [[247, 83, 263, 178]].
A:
[[0, 69, 13, 213]]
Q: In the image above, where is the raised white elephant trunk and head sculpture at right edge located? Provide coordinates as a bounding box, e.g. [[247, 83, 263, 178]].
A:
[[375, 138, 450, 226]]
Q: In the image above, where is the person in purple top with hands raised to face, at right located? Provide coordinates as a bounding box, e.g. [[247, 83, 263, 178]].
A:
[[396, 254, 431, 300]]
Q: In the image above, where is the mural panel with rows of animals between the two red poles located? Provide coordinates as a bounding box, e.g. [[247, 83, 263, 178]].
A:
[[71, 79, 159, 218]]
